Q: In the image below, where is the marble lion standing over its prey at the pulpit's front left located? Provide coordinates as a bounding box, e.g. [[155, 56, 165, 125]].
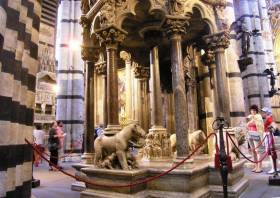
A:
[[94, 124, 146, 170]]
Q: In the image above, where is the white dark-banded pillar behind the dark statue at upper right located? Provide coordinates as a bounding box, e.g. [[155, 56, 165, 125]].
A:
[[236, 0, 270, 109]]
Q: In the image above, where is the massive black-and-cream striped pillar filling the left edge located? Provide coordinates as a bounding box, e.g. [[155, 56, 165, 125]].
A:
[[0, 0, 41, 197]]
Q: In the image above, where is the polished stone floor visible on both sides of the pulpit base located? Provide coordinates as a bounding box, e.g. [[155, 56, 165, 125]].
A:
[[32, 162, 280, 198]]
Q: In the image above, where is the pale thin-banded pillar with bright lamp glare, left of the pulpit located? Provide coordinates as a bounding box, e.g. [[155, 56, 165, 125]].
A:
[[56, 0, 84, 152]]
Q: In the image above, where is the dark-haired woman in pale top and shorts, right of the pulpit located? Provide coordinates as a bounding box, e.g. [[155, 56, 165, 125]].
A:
[[247, 105, 264, 173]]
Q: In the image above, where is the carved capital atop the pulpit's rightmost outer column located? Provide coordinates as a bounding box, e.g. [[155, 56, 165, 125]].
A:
[[204, 31, 230, 51]]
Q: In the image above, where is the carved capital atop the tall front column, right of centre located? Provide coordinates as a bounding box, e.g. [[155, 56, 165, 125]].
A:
[[163, 15, 189, 36]]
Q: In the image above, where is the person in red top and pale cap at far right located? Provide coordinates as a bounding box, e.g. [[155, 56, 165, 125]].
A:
[[261, 107, 276, 174]]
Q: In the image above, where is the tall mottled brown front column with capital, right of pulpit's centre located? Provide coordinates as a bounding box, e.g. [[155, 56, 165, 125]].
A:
[[163, 16, 189, 158]]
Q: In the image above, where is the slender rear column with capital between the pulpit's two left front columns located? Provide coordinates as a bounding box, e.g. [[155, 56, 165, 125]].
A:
[[95, 61, 108, 128]]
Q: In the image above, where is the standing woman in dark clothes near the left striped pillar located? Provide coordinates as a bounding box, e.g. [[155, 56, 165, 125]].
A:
[[48, 122, 60, 171]]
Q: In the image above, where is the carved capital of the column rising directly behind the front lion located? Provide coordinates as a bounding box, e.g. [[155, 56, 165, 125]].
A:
[[95, 25, 127, 45]]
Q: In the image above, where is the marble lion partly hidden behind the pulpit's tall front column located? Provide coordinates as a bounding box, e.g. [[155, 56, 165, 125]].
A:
[[170, 130, 206, 153]]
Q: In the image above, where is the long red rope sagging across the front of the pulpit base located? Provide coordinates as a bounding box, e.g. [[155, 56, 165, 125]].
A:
[[25, 133, 218, 188]]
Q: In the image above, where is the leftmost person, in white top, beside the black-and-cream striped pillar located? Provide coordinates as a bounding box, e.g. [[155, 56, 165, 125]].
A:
[[33, 124, 45, 167]]
